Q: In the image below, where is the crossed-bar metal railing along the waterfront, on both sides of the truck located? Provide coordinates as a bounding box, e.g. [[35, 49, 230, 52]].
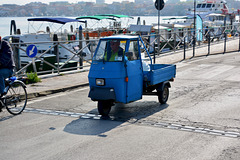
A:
[[11, 25, 240, 75]]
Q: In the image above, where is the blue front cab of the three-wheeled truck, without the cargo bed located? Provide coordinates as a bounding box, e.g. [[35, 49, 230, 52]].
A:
[[88, 35, 143, 103]]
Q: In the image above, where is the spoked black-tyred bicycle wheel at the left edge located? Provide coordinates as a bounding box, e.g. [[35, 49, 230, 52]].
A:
[[5, 82, 27, 115]]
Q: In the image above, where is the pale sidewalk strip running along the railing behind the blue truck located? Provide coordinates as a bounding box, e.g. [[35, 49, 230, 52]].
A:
[[27, 39, 239, 98]]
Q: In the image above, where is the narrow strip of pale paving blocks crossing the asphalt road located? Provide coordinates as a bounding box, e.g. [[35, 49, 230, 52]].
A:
[[24, 108, 240, 138]]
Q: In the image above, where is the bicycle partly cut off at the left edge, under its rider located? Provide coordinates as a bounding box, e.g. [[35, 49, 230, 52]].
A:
[[0, 77, 27, 115]]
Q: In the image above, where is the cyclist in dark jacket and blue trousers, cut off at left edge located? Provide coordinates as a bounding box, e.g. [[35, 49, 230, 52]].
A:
[[0, 36, 15, 112]]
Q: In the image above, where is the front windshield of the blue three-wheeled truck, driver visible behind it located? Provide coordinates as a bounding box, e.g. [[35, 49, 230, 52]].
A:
[[93, 40, 126, 62]]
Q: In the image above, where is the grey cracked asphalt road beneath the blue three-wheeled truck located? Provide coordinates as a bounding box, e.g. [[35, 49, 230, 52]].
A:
[[0, 53, 240, 160]]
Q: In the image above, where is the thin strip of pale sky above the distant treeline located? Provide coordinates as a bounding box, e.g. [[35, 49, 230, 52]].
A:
[[0, 0, 134, 5]]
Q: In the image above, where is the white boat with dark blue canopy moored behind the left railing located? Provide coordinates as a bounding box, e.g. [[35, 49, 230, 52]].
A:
[[3, 17, 91, 60]]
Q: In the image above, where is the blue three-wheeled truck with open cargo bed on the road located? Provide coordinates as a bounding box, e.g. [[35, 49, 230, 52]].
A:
[[88, 35, 176, 116]]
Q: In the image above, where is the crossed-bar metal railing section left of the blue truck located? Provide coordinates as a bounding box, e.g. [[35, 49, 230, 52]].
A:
[[11, 40, 98, 75]]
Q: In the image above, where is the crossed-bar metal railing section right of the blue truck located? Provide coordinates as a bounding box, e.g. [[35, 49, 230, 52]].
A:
[[143, 25, 240, 59]]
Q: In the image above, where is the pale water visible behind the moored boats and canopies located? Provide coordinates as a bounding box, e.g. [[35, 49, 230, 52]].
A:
[[0, 16, 186, 37]]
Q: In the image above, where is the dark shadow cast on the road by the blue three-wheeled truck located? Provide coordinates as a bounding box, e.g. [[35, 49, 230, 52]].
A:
[[64, 101, 168, 137]]
